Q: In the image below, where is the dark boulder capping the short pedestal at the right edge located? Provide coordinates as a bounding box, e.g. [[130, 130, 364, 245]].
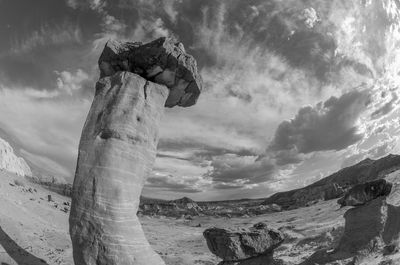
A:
[[338, 179, 392, 206]]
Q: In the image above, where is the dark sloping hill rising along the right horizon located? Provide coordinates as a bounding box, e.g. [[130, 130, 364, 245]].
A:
[[263, 154, 400, 209]]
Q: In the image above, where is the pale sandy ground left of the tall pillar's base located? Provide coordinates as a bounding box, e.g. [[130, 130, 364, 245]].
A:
[[0, 171, 73, 265]]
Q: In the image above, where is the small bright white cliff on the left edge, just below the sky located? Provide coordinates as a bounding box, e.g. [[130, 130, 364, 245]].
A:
[[0, 138, 32, 176]]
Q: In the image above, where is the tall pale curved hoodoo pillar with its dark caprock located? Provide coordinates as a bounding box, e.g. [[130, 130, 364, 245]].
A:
[[69, 38, 202, 265]]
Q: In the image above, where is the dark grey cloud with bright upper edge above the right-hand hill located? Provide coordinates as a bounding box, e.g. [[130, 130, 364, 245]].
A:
[[268, 91, 370, 154]]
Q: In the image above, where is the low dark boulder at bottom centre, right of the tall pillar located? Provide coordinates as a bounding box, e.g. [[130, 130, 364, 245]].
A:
[[203, 223, 283, 264]]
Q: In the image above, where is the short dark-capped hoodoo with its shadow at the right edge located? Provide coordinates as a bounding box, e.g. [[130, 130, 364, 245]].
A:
[[302, 175, 400, 265]]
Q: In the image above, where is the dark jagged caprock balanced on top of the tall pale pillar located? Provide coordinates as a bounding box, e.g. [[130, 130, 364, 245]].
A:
[[99, 38, 203, 107]]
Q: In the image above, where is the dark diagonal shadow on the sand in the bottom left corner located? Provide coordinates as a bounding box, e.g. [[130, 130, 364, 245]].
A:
[[0, 227, 48, 265]]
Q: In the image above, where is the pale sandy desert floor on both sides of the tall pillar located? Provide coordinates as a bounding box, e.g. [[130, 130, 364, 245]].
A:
[[0, 171, 348, 265]]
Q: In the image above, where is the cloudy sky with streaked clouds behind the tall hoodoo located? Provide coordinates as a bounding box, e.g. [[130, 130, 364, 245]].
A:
[[0, 0, 400, 200]]
